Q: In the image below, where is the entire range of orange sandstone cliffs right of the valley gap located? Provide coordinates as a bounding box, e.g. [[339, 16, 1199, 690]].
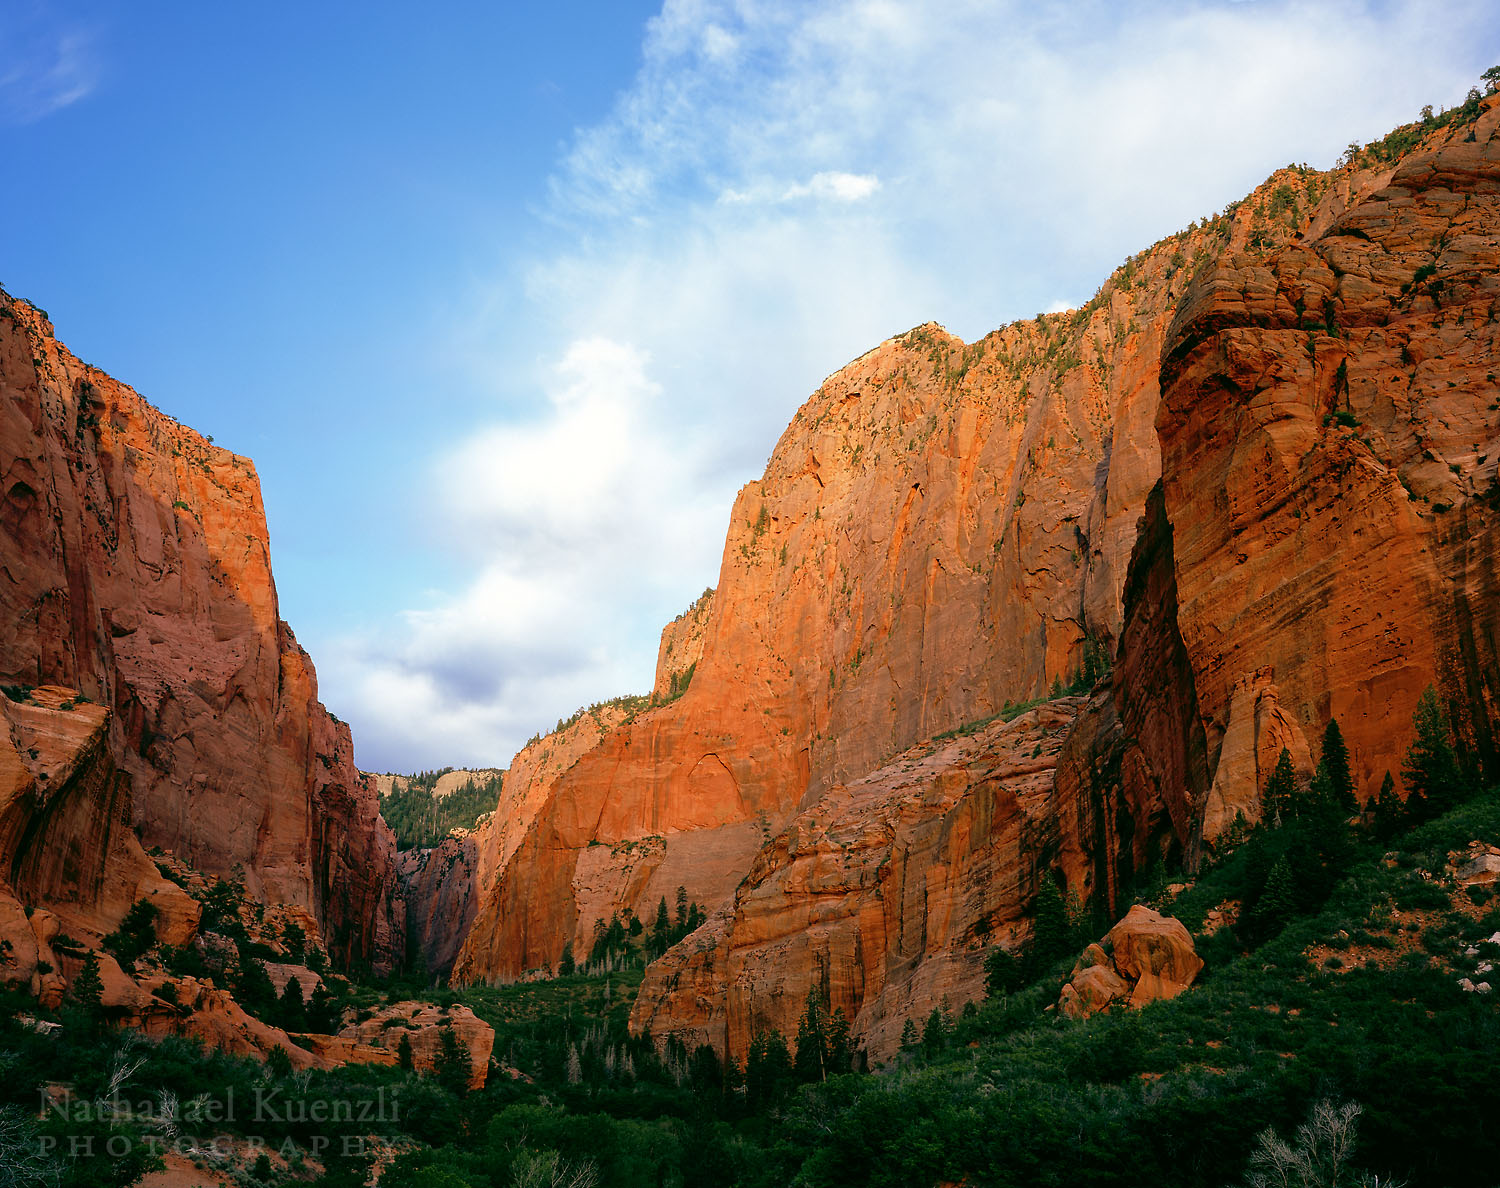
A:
[[461, 101, 1500, 1074]]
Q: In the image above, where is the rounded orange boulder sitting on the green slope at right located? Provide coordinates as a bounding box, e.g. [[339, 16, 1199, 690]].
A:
[[1058, 903, 1203, 1019]]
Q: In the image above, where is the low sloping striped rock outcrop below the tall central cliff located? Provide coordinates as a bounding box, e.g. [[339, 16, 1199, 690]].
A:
[[632, 698, 1083, 1061]]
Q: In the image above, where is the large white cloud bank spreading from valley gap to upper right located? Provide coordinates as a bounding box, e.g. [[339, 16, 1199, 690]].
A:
[[326, 0, 1497, 767]]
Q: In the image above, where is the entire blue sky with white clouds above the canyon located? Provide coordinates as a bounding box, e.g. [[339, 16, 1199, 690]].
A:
[[0, 0, 1500, 770]]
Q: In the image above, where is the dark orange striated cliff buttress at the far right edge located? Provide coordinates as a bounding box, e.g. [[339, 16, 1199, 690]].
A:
[[1157, 99, 1500, 816]]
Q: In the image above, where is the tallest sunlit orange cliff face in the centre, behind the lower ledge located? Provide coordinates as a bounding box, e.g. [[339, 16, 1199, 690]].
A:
[[455, 171, 1325, 980]]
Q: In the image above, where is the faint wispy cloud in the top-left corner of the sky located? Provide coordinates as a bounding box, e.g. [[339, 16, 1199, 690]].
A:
[[0, 13, 99, 125]]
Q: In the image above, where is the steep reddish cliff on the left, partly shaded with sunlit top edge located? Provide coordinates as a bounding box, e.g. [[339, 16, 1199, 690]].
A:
[[0, 297, 404, 965]]
